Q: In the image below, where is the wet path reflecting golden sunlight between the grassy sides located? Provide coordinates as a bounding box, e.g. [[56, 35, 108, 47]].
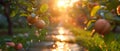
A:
[[28, 27, 85, 51]]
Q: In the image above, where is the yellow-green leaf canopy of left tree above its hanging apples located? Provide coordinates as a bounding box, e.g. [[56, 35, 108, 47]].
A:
[[0, 0, 49, 27]]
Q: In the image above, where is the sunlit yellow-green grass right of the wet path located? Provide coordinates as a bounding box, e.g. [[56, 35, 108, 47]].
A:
[[66, 26, 120, 51]]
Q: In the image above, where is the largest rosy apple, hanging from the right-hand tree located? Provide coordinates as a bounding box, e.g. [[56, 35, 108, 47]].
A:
[[94, 19, 111, 35]]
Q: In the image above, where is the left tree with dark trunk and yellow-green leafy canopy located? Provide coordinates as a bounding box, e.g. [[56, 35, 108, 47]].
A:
[[0, 0, 48, 35]]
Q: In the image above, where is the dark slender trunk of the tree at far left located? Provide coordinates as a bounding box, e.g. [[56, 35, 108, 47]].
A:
[[4, 3, 13, 36]]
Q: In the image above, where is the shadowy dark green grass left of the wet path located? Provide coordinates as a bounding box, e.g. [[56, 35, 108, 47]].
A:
[[0, 28, 47, 51]]
